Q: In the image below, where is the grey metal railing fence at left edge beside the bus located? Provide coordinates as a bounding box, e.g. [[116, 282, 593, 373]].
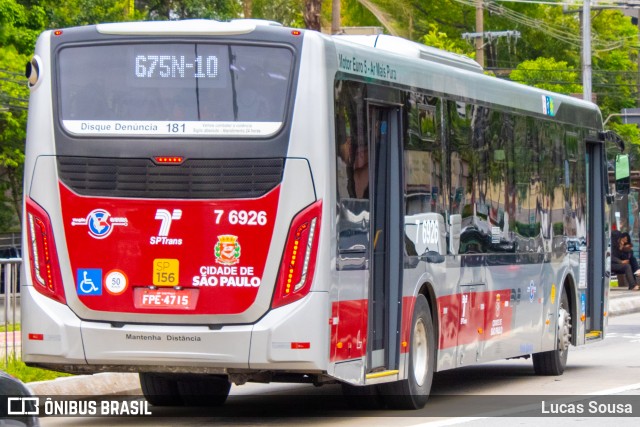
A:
[[0, 258, 22, 365]]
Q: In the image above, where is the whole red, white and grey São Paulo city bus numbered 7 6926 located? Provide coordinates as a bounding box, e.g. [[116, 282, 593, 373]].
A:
[[22, 20, 608, 408]]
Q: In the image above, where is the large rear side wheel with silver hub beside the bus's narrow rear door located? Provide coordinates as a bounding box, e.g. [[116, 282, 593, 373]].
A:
[[380, 295, 435, 409]]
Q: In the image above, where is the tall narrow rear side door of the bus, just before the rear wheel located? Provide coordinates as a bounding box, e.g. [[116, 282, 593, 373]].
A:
[[366, 103, 404, 376]]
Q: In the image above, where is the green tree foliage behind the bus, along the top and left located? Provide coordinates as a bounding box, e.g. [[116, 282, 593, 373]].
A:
[[0, 0, 640, 230]]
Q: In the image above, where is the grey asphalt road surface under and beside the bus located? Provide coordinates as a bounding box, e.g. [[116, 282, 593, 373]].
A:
[[28, 313, 640, 427]]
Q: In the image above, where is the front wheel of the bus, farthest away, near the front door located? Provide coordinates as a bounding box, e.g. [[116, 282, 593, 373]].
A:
[[532, 290, 573, 375]]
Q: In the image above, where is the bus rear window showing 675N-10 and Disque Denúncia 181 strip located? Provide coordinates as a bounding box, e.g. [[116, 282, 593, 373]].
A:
[[58, 43, 293, 137]]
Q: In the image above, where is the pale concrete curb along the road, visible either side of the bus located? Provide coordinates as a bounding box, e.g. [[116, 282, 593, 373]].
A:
[[22, 288, 640, 396]]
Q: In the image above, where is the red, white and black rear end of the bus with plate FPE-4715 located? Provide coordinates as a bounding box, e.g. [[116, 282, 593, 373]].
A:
[[22, 21, 328, 389]]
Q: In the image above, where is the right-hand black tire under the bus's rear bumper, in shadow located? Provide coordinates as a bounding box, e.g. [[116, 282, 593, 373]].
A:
[[178, 375, 231, 406]]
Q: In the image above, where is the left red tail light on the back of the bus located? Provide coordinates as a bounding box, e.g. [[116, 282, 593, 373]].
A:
[[26, 199, 66, 304]]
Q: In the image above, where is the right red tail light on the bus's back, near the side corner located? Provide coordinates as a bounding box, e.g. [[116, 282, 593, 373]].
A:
[[271, 200, 322, 308]]
